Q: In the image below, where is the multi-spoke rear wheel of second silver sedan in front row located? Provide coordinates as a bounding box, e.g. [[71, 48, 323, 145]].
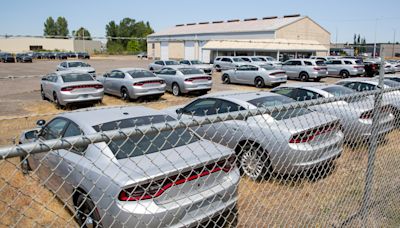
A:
[[238, 142, 271, 180]]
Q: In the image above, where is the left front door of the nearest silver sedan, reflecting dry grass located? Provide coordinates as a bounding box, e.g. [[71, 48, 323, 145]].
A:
[[33, 118, 69, 193]]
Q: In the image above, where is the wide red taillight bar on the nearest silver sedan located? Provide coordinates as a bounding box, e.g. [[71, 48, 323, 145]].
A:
[[118, 156, 236, 201]]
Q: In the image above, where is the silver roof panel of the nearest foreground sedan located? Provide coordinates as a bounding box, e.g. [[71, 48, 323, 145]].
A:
[[59, 106, 167, 129]]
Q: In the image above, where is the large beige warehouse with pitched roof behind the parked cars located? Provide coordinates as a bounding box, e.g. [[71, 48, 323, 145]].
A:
[[147, 15, 330, 62]]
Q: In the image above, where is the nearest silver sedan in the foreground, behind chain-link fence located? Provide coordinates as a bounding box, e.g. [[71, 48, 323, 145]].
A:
[[21, 107, 240, 227]]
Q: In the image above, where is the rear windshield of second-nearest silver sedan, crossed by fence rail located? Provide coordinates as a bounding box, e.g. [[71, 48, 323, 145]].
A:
[[247, 96, 311, 120]]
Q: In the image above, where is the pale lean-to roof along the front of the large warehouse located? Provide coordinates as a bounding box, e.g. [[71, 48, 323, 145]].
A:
[[203, 39, 329, 51]]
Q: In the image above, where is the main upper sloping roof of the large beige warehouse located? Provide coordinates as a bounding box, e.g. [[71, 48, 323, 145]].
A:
[[149, 16, 306, 37]]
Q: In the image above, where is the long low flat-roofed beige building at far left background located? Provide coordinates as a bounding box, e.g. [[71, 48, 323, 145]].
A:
[[0, 37, 102, 53]]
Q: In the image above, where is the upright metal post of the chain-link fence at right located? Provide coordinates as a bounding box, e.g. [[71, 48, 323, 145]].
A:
[[360, 47, 385, 224]]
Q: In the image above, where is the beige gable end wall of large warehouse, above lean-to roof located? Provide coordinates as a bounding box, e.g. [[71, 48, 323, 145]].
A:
[[275, 17, 331, 50]]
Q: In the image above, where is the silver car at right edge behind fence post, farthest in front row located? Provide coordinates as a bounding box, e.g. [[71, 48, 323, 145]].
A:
[[336, 77, 400, 120]]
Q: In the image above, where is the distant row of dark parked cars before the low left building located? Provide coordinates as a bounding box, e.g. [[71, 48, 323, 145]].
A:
[[0, 52, 90, 63]]
